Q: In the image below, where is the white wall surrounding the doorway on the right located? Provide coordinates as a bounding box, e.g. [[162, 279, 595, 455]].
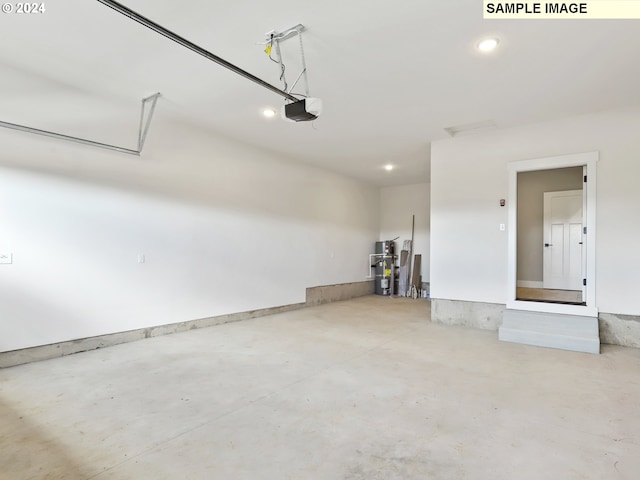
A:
[[431, 109, 640, 315]]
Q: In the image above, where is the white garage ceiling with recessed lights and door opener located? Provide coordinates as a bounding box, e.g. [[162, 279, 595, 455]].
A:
[[0, 0, 640, 185]]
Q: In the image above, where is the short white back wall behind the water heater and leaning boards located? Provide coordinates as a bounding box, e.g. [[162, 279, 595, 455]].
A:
[[380, 183, 430, 282]]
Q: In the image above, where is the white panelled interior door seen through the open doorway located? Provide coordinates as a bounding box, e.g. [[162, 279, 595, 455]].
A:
[[542, 190, 583, 290]]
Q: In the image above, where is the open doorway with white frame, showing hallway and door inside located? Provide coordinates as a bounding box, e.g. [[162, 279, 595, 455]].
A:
[[507, 152, 598, 316]]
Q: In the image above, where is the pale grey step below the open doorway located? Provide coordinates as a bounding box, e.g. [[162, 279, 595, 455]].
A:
[[498, 309, 600, 354]]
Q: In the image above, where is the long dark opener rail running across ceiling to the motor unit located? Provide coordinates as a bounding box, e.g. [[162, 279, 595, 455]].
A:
[[98, 0, 298, 102]]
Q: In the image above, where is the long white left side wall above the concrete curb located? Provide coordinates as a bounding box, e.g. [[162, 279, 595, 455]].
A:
[[0, 116, 379, 351]]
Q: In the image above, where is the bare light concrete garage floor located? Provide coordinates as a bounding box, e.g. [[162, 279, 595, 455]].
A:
[[0, 296, 640, 480]]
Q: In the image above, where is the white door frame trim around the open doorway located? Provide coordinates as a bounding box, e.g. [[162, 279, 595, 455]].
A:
[[507, 152, 599, 317]]
